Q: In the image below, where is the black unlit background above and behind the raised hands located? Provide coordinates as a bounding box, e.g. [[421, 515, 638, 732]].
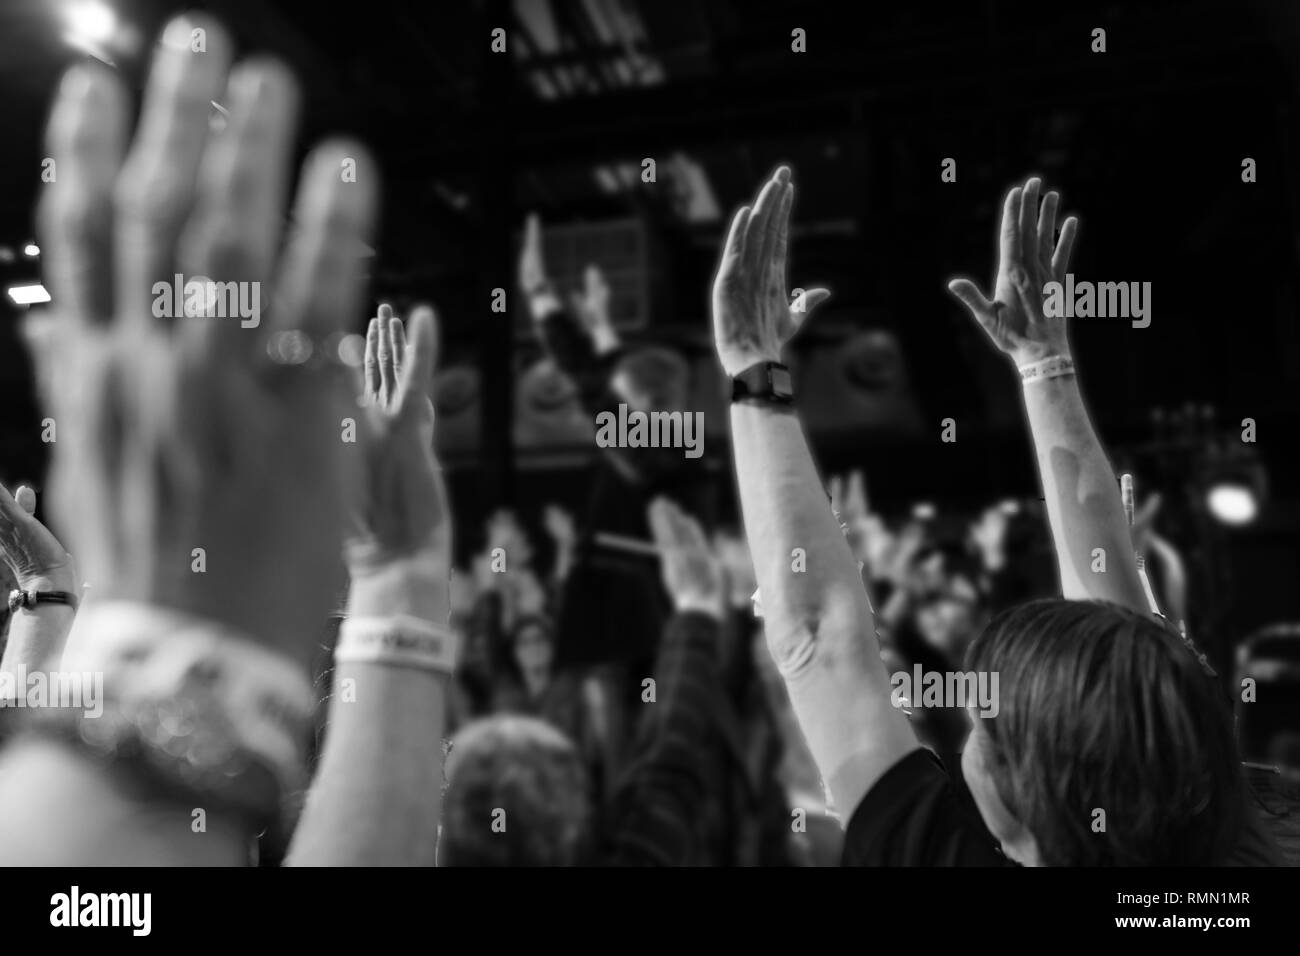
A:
[[0, 0, 1300, 650]]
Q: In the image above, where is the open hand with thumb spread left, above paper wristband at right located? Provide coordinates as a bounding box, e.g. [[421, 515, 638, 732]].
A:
[[948, 177, 1079, 367]]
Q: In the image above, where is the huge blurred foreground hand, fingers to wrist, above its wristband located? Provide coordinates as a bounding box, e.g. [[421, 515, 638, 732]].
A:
[[38, 16, 377, 661]]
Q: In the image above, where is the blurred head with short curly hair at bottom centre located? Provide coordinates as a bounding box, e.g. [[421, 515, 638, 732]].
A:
[[438, 715, 589, 866]]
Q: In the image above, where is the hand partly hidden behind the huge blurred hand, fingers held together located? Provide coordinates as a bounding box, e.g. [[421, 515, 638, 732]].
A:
[[346, 306, 451, 574]]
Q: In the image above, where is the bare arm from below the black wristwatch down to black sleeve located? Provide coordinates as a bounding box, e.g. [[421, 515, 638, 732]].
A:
[[732, 403, 917, 813]]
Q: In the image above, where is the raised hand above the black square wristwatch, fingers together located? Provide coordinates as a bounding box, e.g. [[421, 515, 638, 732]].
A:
[[712, 166, 831, 376]]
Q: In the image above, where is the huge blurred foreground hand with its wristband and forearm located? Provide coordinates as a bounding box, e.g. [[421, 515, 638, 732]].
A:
[[0, 14, 378, 865]]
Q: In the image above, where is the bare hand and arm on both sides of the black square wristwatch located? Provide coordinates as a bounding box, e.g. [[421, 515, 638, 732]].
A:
[[712, 166, 918, 816]]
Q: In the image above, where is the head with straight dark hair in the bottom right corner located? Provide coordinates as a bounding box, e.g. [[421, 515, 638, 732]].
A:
[[962, 598, 1244, 866]]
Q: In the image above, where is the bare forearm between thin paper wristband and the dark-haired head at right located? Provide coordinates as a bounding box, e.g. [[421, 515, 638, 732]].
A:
[[1023, 375, 1147, 613]]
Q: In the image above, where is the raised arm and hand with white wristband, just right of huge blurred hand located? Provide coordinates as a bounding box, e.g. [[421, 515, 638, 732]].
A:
[[289, 306, 454, 866]]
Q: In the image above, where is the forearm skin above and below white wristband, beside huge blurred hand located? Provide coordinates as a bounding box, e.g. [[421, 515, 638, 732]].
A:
[[289, 562, 450, 866]]
